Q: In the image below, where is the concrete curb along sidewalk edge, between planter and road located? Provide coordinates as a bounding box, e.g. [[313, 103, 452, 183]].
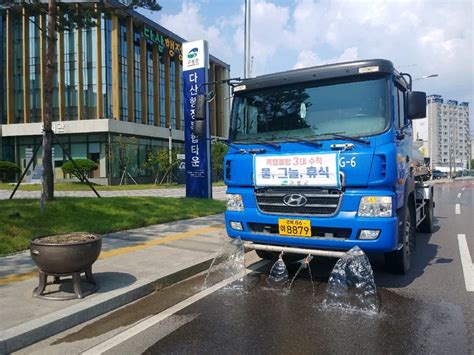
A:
[[0, 256, 214, 355]]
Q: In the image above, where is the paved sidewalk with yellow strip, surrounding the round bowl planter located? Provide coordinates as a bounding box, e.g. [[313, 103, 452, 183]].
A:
[[0, 214, 227, 354]]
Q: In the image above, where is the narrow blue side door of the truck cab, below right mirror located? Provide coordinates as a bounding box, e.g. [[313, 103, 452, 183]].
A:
[[394, 84, 412, 208]]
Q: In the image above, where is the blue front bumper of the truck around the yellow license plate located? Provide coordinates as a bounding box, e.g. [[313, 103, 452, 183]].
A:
[[225, 188, 398, 252]]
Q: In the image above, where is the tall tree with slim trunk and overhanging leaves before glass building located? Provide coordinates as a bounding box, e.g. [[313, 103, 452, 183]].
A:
[[0, 0, 161, 201]]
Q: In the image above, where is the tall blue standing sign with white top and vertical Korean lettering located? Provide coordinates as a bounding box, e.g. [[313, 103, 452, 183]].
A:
[[183, 40, 212, 198]]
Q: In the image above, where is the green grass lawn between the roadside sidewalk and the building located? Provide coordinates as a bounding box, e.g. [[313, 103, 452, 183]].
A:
[[0, 197, 225, 255]]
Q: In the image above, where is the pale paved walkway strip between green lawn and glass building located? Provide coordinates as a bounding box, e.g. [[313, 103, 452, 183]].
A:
[[0, 186, 227, 200]]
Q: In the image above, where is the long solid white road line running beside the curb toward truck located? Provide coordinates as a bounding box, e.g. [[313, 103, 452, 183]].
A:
[[82, 260, 269, 355]]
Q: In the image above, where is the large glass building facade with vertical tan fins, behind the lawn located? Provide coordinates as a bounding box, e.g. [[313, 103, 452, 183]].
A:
[[0, 1, 229, 183]]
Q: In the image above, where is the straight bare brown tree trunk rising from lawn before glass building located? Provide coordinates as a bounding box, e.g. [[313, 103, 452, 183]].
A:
[[42, 0, 56, 201]]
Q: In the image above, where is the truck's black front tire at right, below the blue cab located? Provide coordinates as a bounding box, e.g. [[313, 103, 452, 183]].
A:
[[385, 205, 415, 275]]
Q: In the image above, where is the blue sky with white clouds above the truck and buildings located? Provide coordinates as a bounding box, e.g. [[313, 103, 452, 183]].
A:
[[140, 0, 474, 134]]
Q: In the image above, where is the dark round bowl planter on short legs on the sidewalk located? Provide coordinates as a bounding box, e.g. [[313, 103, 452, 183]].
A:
[[30, 232, 102, 300]]
